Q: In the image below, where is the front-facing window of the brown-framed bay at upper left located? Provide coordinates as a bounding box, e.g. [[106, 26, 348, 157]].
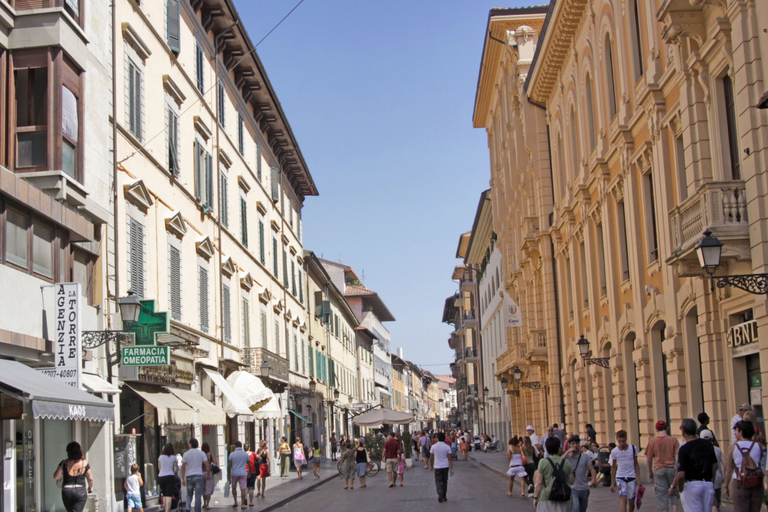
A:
[[14, 67, 48, 168]]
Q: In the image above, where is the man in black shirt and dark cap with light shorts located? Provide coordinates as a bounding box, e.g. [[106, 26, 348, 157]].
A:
[[670, 418, 718, 512]]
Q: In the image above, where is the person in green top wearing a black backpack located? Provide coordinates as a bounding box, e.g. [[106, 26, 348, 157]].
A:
[[533, 436, 573, 512]]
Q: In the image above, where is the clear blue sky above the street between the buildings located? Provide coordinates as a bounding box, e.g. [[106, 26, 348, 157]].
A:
[[235, 0, 535, 373]]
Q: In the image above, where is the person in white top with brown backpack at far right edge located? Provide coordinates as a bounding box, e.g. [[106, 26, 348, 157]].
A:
[[723, 420, 763, 512]]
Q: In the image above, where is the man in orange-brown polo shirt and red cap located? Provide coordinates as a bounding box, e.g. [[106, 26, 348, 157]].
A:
[[645, 421, 680, 512]]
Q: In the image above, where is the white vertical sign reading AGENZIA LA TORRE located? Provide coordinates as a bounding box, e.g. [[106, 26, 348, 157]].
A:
[[54, 283, 82, 388]]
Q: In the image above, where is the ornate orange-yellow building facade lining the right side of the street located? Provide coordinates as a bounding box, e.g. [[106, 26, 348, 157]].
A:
[[475, 0, 768, 446]]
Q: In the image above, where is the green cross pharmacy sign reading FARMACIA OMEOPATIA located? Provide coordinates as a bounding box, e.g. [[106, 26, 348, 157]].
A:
[[120, 300, 171, 366]]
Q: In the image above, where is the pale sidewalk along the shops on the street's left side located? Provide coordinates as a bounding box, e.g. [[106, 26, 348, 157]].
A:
[[146, 458, 340, 512]]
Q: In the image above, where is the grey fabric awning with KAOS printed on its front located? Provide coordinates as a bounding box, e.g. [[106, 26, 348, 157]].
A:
[[0, 359, 115, 421]]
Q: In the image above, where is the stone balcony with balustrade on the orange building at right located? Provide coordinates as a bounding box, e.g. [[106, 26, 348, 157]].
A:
[[669, 180, 749, 262]]
